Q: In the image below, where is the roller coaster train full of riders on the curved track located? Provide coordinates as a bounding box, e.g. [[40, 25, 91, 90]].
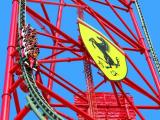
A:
[[21, 24, 39, 70]]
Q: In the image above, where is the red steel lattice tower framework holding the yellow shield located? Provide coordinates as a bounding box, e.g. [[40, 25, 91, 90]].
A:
[[0, 0, 160, 120]]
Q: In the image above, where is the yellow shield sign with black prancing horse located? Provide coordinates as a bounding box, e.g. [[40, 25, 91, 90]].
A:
[[78, 19, 127, 81]]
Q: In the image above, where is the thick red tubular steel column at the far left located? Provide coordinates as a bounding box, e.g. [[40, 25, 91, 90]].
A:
[[1, 0, 18, 120]]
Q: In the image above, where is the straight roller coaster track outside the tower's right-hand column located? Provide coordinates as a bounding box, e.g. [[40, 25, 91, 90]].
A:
[[135, 0, 160, 75]]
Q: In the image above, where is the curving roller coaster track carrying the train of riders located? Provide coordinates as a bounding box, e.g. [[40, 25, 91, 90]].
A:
[[18, 0, 63, 120]]
